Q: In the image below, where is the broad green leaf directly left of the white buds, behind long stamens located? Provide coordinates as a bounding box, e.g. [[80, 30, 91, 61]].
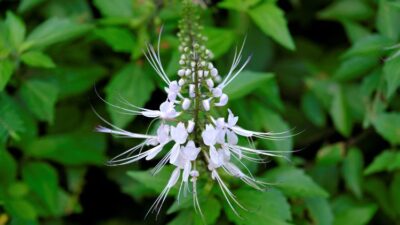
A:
[[106, 64, 155, 127]]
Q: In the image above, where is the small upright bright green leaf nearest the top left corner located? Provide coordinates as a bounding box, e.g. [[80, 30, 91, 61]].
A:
[[5, 11, 26, 49]]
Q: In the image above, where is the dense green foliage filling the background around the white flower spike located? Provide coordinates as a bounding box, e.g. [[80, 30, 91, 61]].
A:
[[0, 0, 400, 225]]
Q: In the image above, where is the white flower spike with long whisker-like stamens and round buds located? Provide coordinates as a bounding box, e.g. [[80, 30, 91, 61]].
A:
[[97, 0, 290, 217]]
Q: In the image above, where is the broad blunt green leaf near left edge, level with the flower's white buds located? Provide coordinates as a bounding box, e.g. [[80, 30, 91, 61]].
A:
[[19, 80, 58, 123]]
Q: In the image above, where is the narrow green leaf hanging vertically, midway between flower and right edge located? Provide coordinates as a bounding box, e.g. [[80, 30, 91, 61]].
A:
[[330, 87, 353, 137]]
